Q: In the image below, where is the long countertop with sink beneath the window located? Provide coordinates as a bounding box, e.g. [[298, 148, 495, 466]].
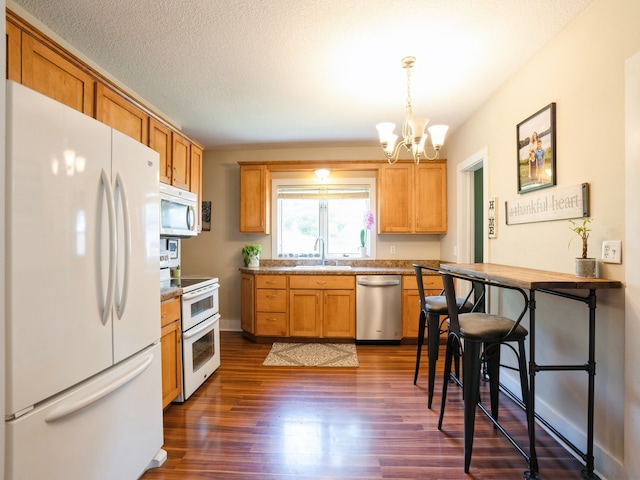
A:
[[240, 260, 440, 275]]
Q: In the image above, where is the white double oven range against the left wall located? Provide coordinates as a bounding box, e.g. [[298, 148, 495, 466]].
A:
[[160, 238, 220, 402]]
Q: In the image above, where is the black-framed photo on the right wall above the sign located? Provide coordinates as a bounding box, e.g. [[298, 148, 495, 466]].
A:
[[516, 103, 556, 193]]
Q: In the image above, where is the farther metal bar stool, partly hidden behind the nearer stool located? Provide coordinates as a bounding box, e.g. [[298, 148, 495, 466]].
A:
[[413, 264, 474, 408]]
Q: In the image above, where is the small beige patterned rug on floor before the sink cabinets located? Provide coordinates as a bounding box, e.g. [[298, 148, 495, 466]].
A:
[[262, 342, 360, 367]]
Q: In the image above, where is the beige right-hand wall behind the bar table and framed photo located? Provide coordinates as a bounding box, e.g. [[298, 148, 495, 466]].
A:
[[442, 0, 640, 479]]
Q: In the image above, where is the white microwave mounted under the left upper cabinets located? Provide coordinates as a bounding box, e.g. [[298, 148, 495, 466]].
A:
[[160, 183, 198, 237]]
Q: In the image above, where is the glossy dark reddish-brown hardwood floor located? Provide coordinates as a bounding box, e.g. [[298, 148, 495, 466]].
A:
[[142, 332, 582, 480]]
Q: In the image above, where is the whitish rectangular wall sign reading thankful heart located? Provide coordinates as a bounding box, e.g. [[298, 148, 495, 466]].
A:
[[505, 183, 589, 225]]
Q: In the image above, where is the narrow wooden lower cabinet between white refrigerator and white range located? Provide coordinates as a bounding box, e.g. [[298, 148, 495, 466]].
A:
[[160, 298, 182, 408]]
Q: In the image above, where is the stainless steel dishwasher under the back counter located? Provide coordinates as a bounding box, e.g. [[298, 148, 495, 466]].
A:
[[356, 275, 402, 341]]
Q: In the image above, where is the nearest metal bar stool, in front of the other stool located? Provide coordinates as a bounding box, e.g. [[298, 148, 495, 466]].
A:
[[438, 271, 534, 473]]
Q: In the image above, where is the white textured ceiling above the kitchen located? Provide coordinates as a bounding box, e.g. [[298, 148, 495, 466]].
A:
[[7, 0, 592, 148]]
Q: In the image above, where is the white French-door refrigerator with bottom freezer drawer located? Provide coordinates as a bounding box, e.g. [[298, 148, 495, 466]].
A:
[[4, 81, 166, 480]]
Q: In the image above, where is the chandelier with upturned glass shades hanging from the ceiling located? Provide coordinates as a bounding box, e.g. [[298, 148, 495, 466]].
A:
[[376, 57, 449, 165]]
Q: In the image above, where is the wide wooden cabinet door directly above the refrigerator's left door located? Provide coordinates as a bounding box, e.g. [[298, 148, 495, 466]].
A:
[[20, 32, 97, 116]]
